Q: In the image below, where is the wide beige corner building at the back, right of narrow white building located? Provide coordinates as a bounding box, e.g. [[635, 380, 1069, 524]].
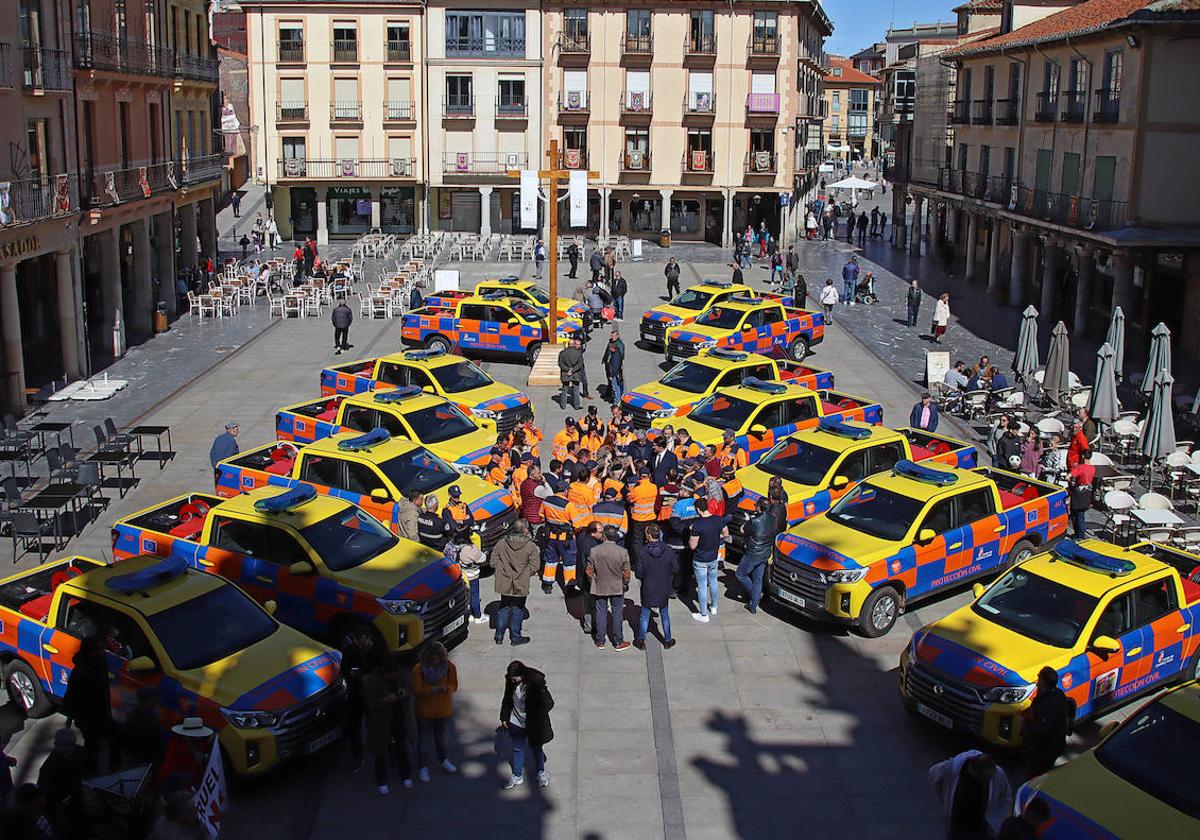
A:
[[540, 0, 832, 245]]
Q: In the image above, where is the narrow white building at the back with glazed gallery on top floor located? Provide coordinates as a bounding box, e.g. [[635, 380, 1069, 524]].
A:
[[424, 0, 548, 235]]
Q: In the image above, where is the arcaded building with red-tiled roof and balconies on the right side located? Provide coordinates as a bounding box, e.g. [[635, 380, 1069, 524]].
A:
[[910, 0, 1200, 353]]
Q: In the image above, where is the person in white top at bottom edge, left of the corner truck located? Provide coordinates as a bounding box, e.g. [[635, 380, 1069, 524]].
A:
[[929, 750, 1013, 840]]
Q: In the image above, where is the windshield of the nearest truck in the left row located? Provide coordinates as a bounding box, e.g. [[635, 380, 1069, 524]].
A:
[[146, 583, 280, 671]]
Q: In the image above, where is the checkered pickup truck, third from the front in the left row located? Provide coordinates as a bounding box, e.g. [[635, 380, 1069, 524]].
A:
[[216, 428, 517, 552]]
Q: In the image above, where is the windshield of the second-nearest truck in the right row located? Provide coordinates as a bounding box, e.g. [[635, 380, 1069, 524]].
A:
[[971, 568, 1098, 648]]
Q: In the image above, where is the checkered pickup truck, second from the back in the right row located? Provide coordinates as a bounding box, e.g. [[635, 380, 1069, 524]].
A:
[[666, 295, 824, 361]]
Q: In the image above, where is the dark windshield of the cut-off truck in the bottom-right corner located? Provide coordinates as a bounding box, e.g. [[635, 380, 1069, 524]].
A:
[[1096, 701, 1200, 820]]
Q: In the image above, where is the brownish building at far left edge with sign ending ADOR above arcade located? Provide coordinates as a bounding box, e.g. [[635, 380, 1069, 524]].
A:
[[0, 0, 86, 406]]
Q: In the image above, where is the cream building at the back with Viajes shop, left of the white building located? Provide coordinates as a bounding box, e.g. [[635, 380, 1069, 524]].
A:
[[241, 0, 427, 244]]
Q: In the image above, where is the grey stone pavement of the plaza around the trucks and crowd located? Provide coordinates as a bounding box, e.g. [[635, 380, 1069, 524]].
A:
[[0, 244, 1132, 840]]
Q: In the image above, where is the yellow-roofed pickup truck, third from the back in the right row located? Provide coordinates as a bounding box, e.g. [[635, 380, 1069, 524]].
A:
[[620, 347, 833, 428]]
